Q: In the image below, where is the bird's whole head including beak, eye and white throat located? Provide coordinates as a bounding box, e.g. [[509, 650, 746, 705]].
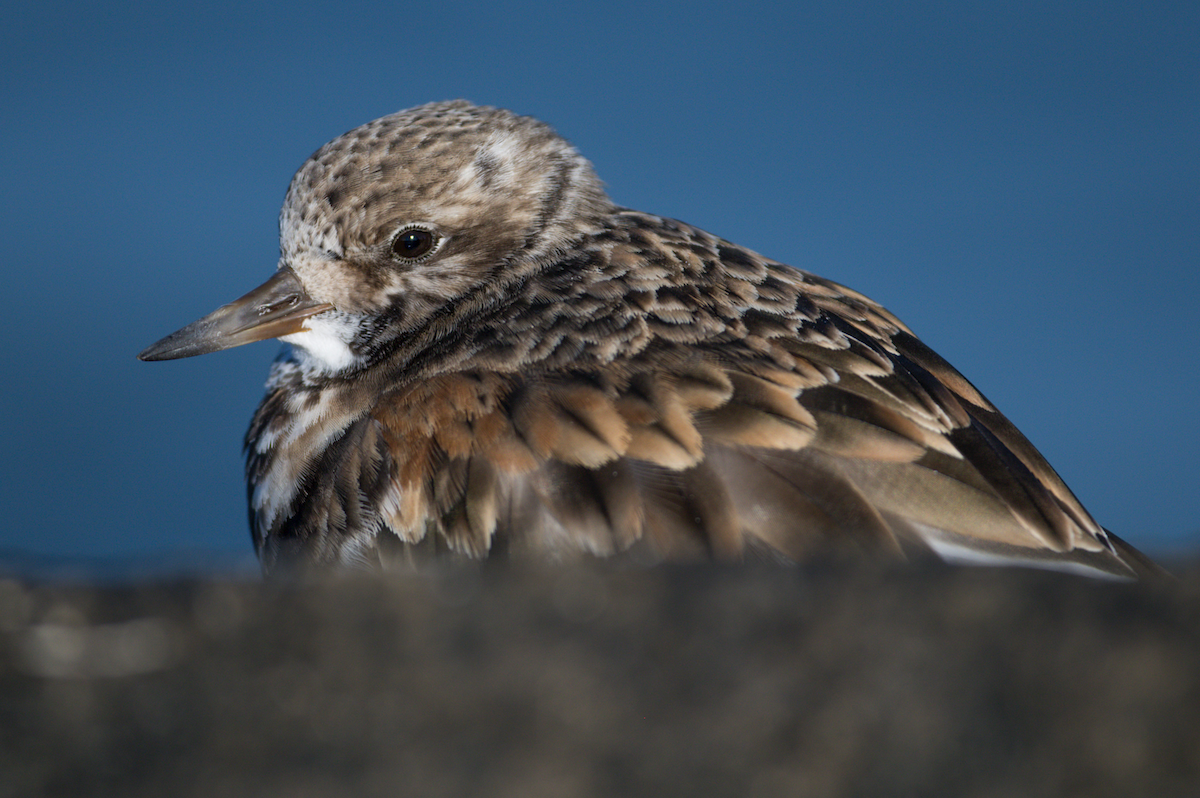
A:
[[138, 101, 611, 373]]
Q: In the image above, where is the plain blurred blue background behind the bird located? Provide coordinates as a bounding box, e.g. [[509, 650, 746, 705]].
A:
[[0, 0, 1200, 564]]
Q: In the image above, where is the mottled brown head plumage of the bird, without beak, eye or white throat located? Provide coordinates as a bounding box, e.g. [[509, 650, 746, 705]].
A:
[[280, 101, 610, 316]]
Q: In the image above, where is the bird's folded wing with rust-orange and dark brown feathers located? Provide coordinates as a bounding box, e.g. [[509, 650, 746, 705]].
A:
[[355, 329, 1132, 576]]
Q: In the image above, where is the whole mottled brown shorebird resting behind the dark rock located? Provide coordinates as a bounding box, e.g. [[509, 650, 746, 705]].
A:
[[138, 100, 1158, 578]]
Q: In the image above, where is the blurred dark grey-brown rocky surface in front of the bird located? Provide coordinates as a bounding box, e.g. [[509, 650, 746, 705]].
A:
[[0, 565, 1200, 798]]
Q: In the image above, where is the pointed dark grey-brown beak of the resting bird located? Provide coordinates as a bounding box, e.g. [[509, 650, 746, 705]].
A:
[[138, 268, 334, 360]]
